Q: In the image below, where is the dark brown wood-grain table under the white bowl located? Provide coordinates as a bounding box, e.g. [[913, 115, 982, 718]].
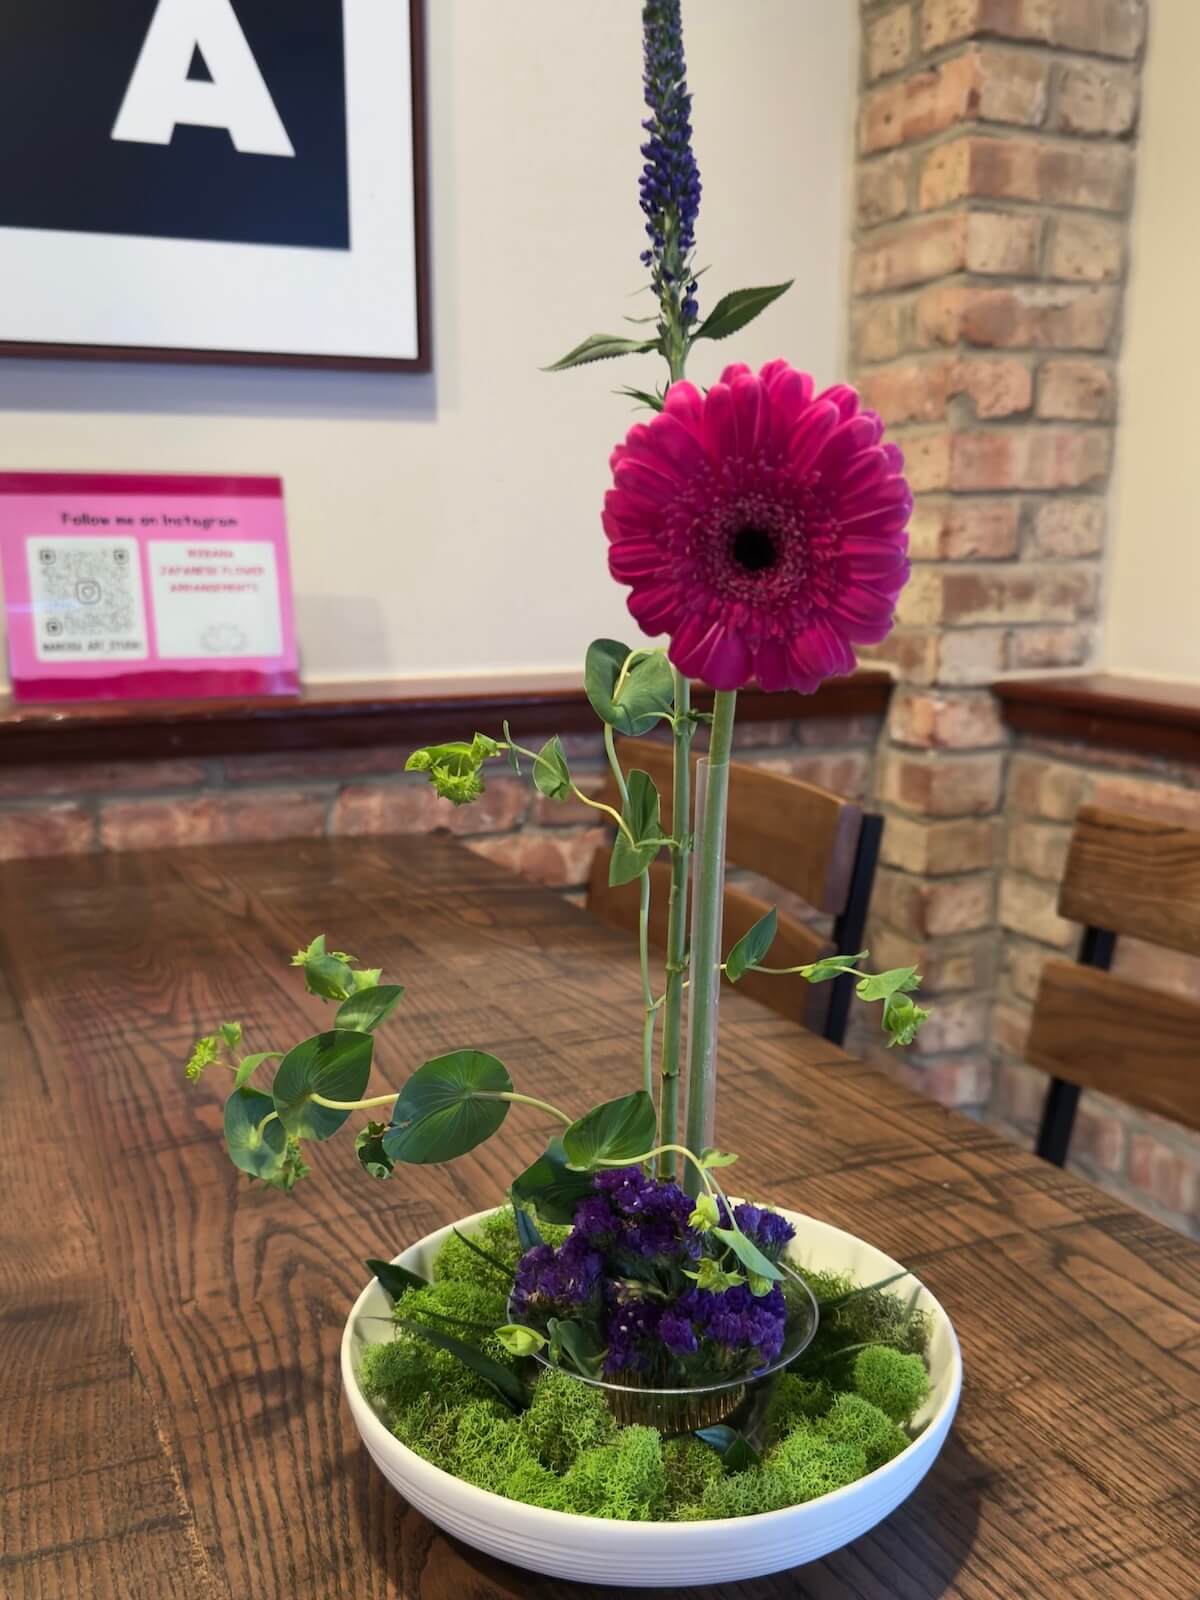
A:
[[0, 837, 1200, 1600]]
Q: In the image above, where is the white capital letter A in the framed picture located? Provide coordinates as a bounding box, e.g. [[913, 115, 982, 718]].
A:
[[112, 0, 296, 155]]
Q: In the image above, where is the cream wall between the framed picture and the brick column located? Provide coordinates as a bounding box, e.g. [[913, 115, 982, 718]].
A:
[[0, 0, 856, 680]]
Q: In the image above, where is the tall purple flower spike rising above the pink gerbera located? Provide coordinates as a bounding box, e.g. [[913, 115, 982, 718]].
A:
[[638, 0, 701, 326]]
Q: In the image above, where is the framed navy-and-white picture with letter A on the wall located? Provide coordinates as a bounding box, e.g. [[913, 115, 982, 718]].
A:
[[0, 0, 430, 371]]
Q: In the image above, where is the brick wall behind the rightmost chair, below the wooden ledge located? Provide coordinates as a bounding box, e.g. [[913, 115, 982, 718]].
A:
[[989, 738, 1200, 1238]]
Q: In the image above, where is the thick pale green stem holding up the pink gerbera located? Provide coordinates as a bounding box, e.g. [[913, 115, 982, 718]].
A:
[[683, 690, 738, 1195]]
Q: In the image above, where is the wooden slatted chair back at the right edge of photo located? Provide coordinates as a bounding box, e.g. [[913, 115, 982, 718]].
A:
[[1026, 806, 1200, 1166]]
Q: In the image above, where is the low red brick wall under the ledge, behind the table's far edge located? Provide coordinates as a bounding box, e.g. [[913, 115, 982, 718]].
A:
[[0, 717, 880, 891]]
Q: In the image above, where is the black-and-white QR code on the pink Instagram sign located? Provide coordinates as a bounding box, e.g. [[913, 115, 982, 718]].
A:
[[26, 538, 147, 661]]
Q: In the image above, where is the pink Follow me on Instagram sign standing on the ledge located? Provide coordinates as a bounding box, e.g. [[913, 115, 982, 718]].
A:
[[0, 472, 299, 701]]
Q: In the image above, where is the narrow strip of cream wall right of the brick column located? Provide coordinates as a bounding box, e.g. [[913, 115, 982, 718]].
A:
[[1104, 3, 1200, 682]]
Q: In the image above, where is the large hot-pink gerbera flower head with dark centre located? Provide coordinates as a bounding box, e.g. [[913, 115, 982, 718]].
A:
[[603, 362, 912, 694]]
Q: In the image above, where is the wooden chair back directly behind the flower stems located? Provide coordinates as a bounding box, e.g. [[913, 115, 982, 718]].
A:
[[587, 739, 882, 1043]]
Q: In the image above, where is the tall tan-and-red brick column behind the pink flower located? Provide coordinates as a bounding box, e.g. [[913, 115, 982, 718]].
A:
[[851, 0, 1146, 1107]]
